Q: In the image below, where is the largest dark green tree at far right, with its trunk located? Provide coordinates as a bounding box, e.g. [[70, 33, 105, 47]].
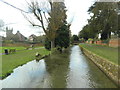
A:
[[88, 2, 118, 39]]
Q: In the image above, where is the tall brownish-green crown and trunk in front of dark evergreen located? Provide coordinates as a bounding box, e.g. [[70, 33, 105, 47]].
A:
[[48, 2, 67, 48]]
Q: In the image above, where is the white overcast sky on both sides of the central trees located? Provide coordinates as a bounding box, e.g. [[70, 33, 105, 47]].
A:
[[0, 0, 95, 37]]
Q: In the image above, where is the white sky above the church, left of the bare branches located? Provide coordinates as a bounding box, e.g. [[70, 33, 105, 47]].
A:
[[0, 0, 43, 37]]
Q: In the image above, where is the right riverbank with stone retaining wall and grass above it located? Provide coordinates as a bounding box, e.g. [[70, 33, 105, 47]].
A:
[[80, 44, 120, 86]]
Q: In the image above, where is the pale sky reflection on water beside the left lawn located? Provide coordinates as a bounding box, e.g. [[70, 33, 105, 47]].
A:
[[3, 60, 48, 88]]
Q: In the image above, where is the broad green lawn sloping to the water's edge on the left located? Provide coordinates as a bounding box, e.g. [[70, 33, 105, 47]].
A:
[[0, 48, 49, 77]]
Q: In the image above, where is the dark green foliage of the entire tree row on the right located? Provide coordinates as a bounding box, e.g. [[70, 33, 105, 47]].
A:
[[79, 2, 119, 40]]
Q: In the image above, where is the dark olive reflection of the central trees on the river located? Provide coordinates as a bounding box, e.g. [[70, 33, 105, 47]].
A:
[[45, 48, 70, 88]]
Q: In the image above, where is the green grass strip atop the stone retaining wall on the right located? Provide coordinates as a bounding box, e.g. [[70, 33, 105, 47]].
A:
[[80, 44, 118, 64]]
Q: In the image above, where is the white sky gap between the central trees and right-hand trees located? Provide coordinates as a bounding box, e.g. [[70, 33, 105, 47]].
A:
[[65, 0, 94, 34]]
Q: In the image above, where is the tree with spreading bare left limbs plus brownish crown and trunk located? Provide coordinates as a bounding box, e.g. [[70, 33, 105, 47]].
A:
[[23, 0, 66, 48]]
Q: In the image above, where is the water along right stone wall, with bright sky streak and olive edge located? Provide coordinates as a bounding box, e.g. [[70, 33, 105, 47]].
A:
[[67, 46, 116, 88]]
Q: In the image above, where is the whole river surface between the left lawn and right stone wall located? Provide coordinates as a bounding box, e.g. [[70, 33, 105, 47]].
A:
[[0, 45, 116, 88]]
